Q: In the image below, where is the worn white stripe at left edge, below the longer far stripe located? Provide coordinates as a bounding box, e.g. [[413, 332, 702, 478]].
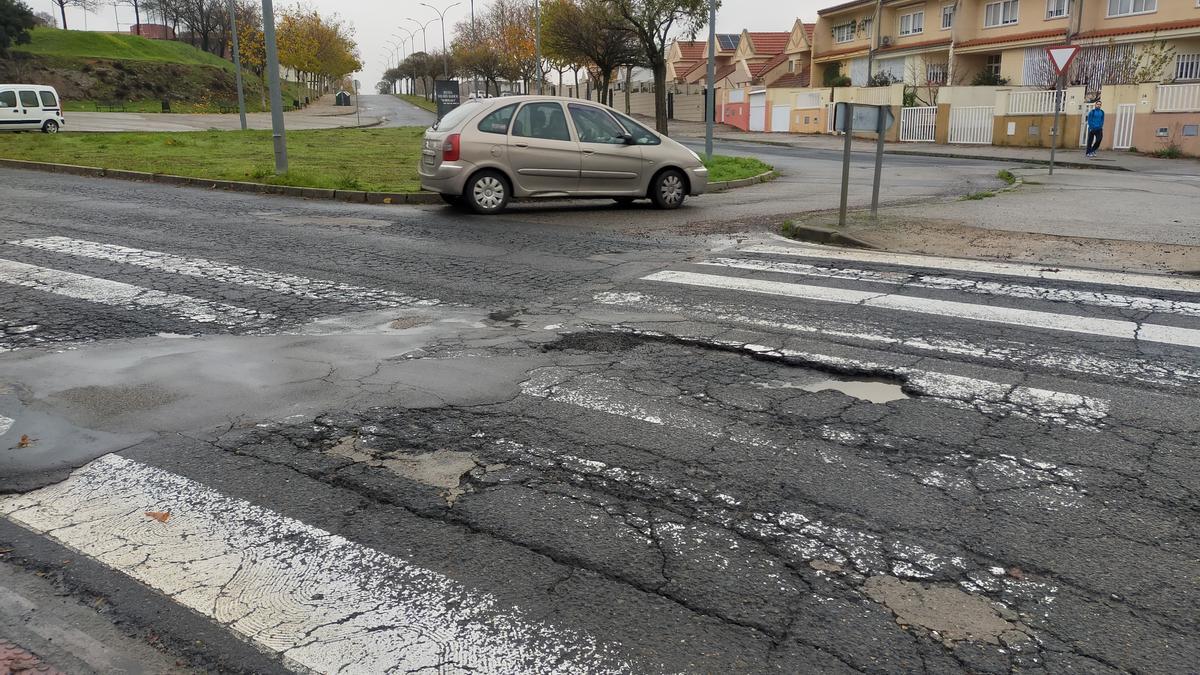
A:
[[0, 258, 275, 327]]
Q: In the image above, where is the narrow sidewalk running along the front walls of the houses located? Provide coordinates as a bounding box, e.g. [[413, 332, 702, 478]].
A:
[[671, 121, 1200, 175]]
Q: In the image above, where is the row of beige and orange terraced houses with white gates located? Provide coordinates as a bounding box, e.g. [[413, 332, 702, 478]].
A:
[[667, 0, 1200, 155]]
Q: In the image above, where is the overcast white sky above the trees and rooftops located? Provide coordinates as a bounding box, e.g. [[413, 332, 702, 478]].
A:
[[49, 0, 839, 88]]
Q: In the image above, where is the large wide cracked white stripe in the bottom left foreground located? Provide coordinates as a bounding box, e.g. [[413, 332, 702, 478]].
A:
[[0, 455, 640, 674]]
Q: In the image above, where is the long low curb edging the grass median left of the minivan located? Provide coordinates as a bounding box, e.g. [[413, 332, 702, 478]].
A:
[[0, 159, 442, 204]]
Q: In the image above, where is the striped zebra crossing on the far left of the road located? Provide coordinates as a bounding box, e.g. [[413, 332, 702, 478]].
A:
[[0, 237, 442, 352]]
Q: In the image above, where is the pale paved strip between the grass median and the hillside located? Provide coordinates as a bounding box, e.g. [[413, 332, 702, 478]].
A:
[[62, 96, 382, 132]]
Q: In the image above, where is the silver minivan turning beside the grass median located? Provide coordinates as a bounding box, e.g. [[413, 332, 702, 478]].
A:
[[419, 96, 708, 214]]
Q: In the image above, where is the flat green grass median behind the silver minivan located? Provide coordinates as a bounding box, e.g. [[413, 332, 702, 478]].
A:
[[0, 127, 770, 192]]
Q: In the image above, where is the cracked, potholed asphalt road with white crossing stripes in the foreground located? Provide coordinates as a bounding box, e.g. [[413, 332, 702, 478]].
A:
[[0, 164, 1200, 674]]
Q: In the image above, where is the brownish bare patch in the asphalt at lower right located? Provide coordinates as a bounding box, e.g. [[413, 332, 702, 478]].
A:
[[865, 577, 1030, 645]]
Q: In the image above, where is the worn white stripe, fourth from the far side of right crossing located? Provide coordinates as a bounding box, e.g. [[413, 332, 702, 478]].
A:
[[594, 292, 1200, 388]]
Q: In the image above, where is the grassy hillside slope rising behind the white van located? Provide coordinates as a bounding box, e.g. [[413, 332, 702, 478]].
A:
[[0, 28, 295, 112]]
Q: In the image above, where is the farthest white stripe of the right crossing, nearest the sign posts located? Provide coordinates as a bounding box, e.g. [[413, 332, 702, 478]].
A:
[[739, 245, 1200, 293]]
